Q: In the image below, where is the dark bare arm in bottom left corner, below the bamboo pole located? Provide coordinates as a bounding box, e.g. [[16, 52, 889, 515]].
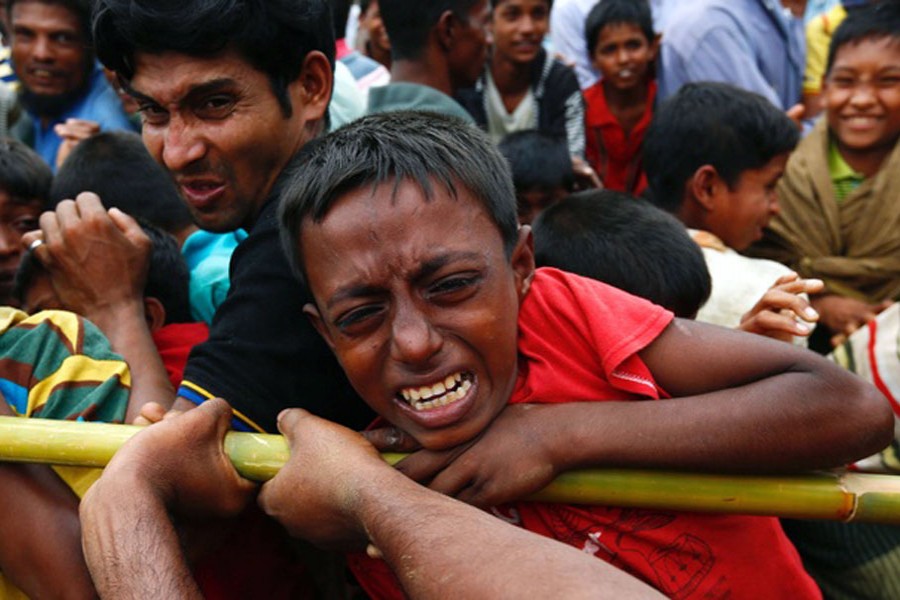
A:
[[0, 399, 95, 598]]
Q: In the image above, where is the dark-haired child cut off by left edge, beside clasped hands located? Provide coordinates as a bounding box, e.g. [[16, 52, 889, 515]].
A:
[[0, 138, 53, 305]]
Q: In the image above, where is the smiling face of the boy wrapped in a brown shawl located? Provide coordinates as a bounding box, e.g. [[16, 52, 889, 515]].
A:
[[822, 37, 900, 156]]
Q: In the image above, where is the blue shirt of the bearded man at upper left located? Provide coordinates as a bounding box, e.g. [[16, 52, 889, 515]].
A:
[[29, 66, 135, 170]]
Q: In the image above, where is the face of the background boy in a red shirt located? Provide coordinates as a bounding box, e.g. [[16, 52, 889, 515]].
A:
[[591, 23, 659, 90]]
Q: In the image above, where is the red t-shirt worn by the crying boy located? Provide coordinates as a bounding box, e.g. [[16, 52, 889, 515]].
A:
[[348, 269, 821, 600]]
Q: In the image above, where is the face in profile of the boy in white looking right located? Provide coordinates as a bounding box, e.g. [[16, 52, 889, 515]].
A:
[[705, 152, 790, 251]]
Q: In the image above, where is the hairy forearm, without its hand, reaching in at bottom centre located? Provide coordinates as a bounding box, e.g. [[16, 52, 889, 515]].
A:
[[358, 474, 662, 599]]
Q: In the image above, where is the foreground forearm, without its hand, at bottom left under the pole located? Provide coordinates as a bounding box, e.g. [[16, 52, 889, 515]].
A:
[[81, 473, 202, 600]]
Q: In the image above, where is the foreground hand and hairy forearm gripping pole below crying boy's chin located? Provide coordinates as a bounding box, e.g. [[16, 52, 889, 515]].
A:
[[259, 409, 661, 599]]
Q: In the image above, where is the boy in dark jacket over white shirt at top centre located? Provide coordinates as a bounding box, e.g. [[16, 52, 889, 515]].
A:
[[457, 0, 584, 159]]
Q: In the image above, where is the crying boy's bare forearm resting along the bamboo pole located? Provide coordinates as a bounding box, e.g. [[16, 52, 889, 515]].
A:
[[547, 366, 890, 473]]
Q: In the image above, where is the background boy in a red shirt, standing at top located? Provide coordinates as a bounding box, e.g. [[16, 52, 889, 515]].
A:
[[584, 0, 659, 195]]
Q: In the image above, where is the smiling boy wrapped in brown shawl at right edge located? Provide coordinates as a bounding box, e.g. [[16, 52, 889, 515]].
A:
[[751, 2, 900, 354]]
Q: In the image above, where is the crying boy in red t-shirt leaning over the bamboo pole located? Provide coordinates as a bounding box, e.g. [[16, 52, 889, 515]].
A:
[[280, 113, 890, 598]]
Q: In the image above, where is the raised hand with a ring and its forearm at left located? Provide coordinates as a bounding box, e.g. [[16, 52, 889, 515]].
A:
[[23, 192, 174, 423]]
